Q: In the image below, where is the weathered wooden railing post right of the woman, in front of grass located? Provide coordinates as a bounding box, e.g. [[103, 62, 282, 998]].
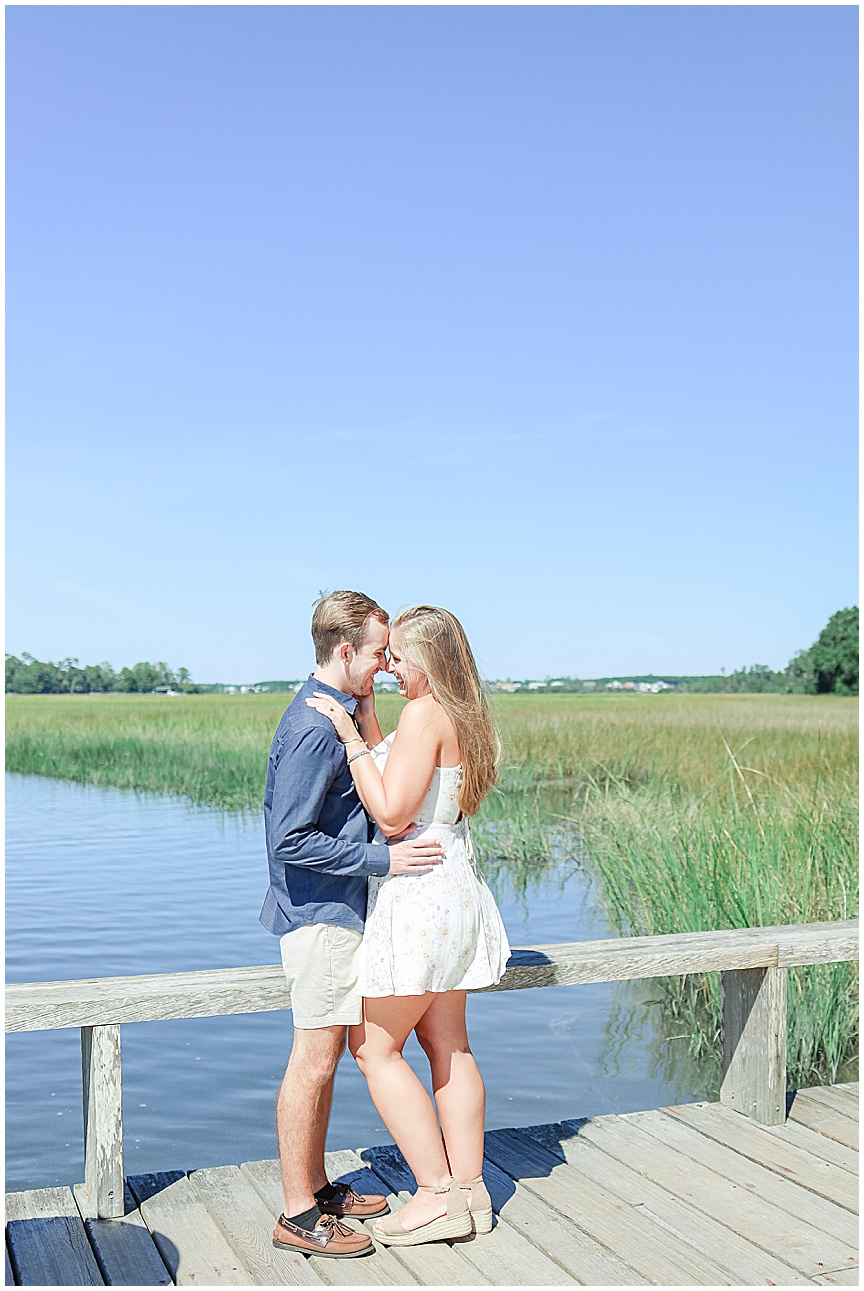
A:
[[721, 968, 787, 1126]]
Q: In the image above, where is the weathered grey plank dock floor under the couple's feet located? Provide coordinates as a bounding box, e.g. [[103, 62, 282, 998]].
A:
[[6, 1084, 859, 1286]]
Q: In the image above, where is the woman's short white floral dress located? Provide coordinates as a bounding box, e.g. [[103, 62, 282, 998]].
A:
[[358, 735, 510, 997]]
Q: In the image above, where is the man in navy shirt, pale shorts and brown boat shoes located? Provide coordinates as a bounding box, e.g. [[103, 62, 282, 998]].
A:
[[261, 591, 443, 1257]]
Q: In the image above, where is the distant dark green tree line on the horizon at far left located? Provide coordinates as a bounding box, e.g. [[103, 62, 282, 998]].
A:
[[6, 653, 204, 695]]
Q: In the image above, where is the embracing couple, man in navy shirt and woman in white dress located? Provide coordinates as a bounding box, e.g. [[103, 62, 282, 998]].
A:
[[261, 591, 510, 1257]]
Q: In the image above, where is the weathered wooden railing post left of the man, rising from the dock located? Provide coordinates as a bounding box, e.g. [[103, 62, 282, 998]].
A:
[[76, 1025, 124, 1219]]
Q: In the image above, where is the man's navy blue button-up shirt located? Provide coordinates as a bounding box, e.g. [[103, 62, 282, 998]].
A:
[[260, 676, 390, 937]]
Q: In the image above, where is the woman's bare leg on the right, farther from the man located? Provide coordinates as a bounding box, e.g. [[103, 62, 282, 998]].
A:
[[416, 990, 486, 1184]]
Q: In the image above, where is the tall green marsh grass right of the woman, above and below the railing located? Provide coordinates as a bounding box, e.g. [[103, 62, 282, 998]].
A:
[[485, 696, 858, 1088]]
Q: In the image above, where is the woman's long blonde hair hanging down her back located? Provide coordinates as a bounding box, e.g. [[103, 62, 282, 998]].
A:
[[390, 605, 501, 816]]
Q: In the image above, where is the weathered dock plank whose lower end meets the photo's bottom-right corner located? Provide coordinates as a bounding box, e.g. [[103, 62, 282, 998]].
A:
[[580, 1113, 856, 1278]]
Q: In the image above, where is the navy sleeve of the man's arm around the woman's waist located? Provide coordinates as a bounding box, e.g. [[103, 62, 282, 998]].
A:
[[267, 726, 390, 878]]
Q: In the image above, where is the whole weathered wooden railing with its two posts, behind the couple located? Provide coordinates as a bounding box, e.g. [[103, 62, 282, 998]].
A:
[[6, 919, 858, 1217]]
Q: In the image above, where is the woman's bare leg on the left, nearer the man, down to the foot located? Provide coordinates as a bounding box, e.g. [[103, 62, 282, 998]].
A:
[[349, 991, 451, 1229]]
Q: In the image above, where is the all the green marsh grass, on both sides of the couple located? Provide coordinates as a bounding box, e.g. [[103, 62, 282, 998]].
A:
[[6, 695, 858, 1084]]
